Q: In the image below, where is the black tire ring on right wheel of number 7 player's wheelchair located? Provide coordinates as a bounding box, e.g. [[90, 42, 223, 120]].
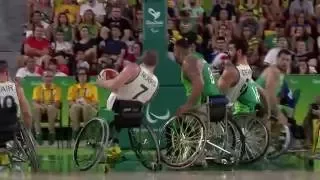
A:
[[128, 121, 161, 171]]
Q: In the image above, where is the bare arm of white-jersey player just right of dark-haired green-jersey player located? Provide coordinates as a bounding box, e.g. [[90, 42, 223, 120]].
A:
[[218, 63, 237, 92]]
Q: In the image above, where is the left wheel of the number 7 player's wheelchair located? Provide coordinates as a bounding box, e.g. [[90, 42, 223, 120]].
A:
[[73, 118, 109, 171]]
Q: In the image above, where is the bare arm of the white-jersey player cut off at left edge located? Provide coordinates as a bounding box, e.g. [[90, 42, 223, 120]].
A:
[[16, 84, 32, 128]]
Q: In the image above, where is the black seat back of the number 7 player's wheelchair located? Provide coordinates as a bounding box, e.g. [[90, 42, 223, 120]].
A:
[[112, 100, 144, 129]]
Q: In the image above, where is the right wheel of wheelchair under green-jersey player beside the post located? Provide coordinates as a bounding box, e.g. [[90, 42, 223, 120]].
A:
[[206, 120, 245, 166]]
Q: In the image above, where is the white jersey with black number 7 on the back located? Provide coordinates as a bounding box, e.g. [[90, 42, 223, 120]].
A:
[[115, 65, 159, 104]]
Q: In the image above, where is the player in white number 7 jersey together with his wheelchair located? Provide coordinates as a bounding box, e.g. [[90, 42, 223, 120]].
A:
[[74, 51, 160, 170]]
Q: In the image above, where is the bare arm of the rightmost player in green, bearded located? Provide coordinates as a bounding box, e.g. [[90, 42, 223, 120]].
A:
[[264, 68, 280, 107]]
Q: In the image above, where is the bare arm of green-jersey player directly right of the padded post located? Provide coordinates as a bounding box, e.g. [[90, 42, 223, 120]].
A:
[[182, 56, 204, 106]]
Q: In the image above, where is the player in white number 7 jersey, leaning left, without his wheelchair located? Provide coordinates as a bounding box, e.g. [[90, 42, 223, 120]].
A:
[[97, 51, 159, 109]]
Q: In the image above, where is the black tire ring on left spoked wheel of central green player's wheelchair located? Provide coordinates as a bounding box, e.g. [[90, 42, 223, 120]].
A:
[[159, 113, 207, 170]]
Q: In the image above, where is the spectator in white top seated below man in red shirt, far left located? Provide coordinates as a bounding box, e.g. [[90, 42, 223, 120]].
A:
[[16, 57, 41, 81]]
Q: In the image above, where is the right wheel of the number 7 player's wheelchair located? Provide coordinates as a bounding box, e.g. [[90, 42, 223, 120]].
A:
[[128, 122, 161, 171]]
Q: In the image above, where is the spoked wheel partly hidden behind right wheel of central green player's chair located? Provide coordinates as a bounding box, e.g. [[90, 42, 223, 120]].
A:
[[233, 114, 269, 164]]
